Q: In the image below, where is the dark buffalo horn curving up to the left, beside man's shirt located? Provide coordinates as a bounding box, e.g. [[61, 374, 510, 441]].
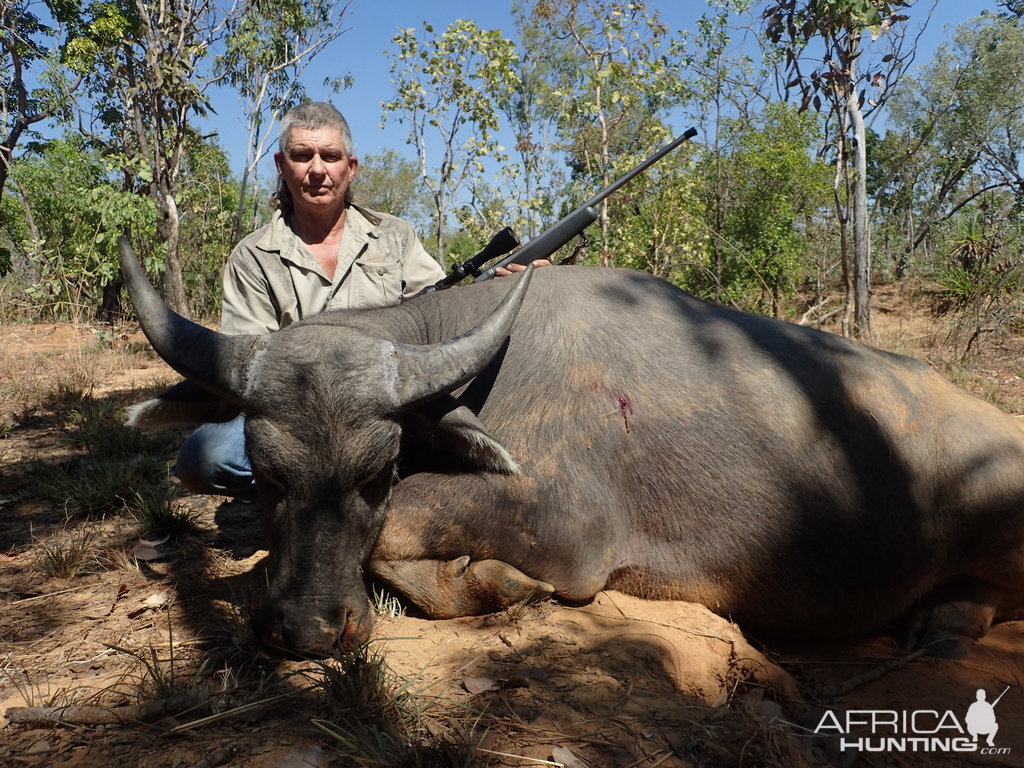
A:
[[118, 237, 254, 406]]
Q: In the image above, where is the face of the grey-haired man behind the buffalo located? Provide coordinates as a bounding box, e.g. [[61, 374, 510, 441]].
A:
[[273, 128, 358, 213]]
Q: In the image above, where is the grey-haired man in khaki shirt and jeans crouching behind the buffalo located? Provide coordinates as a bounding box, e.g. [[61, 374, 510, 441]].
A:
[[175, 102, 547, 498]]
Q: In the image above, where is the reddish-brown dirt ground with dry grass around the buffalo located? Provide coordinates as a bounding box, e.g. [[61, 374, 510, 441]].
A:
[[0, 287, 1024, 768]]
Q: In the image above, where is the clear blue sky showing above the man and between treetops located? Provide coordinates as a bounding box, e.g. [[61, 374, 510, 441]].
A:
[[199, 0, 997, 183]]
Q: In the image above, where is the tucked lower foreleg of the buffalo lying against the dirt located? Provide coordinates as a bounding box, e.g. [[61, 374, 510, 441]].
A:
[[370, 555, 555, 618]]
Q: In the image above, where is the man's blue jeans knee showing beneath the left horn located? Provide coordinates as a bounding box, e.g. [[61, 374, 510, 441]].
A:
[[174, 415, 256, 499]]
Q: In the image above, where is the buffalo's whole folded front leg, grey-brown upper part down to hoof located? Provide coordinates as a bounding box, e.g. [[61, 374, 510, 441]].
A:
[[368, 473, 622, 618]]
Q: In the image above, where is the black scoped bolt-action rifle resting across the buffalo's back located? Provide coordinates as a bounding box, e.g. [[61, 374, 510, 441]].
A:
[[420, 128, 697, 295]]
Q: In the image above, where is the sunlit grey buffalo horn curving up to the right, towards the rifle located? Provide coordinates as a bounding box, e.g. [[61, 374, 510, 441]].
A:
[[394, 264, 534, 408]]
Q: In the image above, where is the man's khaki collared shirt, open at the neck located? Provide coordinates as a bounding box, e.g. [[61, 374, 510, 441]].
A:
[[220, 205, 444, 335]]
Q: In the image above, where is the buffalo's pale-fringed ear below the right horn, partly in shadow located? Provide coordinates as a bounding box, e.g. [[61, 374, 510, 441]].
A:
[[402, 395, 519, 475]]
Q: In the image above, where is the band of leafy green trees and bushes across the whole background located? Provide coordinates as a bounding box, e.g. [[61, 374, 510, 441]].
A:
[[6, 0, 1024, 318]]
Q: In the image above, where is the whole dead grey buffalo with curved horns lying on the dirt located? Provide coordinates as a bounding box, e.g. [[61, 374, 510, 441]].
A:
[[122, 237, 1024, 654]]
